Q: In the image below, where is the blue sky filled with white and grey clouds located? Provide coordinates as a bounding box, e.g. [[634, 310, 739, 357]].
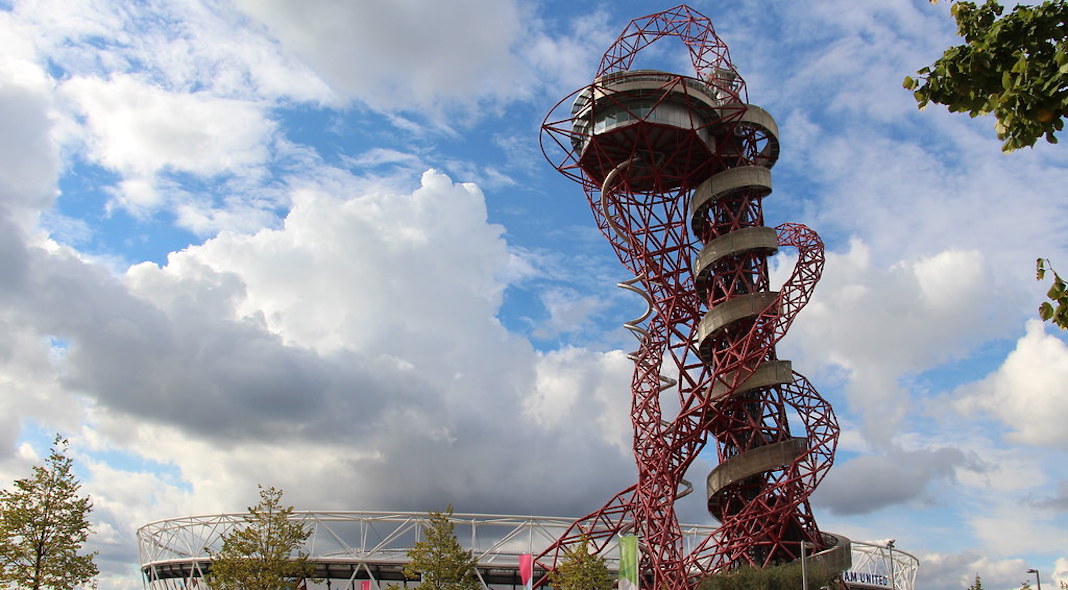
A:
[[0, 0, 1068, 590]]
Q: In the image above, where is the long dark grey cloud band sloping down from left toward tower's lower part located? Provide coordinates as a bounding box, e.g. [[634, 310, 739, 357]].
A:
[[2, 249, 631, 515]]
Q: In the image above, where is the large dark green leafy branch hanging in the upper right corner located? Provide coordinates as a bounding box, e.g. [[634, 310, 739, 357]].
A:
[[904, 0, 1068, 152]]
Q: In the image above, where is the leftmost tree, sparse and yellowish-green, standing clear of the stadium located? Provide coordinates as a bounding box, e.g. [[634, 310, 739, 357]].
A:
[[0, 435, 97, 590]]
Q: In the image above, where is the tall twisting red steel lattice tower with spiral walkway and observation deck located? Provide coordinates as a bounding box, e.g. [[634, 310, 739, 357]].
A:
[[538, 5, 838, 590]]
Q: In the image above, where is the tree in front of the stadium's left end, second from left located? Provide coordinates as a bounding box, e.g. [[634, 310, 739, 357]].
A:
[[207, 485, 315, 590]]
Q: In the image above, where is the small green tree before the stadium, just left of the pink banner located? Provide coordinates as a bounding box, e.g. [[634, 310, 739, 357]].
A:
[[404, 504, 482, 590]]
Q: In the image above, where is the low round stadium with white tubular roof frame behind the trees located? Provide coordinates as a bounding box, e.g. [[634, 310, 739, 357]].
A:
[[138, 512, 918, 590]]
